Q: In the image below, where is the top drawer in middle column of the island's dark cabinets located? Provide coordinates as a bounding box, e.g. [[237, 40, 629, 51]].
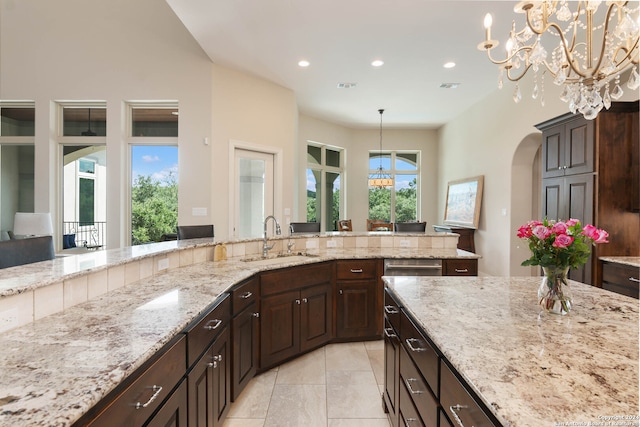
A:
[[400, 311, 440, 397]]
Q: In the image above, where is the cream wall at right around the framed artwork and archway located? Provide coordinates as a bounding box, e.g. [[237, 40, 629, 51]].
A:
[[438, 70, 638, 276]]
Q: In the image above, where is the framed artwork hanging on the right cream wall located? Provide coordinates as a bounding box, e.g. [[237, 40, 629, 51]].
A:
[[444, 175, 484, 228]]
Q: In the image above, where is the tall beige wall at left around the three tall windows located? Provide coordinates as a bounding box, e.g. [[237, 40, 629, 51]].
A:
[[0, 0, 212, 247]]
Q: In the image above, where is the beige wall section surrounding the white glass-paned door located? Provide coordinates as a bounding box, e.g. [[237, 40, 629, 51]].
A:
[[211, 66, 298, 240]]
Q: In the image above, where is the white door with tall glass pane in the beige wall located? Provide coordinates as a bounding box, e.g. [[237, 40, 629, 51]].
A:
[[232, 148, 274, 239]]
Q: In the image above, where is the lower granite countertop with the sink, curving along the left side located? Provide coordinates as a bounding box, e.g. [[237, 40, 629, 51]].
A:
[[0, 247, 478, 427]]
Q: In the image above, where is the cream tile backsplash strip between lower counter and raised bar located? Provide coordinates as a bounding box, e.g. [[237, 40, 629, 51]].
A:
[[0, 233, 458, 333]]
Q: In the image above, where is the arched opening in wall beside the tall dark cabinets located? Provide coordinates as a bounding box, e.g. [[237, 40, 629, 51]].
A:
[[509, 133, 542, 276]]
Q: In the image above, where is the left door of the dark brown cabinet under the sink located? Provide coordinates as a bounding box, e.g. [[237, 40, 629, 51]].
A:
[[260, 291, 302, 369]]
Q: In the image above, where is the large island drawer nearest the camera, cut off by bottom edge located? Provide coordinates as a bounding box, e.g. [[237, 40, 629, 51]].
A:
[[440, 360, 496, 427]]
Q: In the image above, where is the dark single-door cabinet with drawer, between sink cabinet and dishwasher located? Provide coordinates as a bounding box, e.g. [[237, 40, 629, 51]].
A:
[[335, 259, 383, 339]]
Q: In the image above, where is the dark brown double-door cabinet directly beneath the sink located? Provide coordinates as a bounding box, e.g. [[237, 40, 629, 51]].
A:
[[260, 263, 333, 369]]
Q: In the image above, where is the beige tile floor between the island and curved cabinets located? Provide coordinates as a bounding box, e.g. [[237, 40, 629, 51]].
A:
[[223, 340, 389, 427]]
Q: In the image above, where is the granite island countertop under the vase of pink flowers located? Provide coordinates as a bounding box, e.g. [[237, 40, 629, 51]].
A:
[[385, 277, 640, 427]]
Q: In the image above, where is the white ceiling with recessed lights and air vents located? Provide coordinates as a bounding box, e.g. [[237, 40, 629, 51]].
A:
[[167, 0, 523, 129]]
